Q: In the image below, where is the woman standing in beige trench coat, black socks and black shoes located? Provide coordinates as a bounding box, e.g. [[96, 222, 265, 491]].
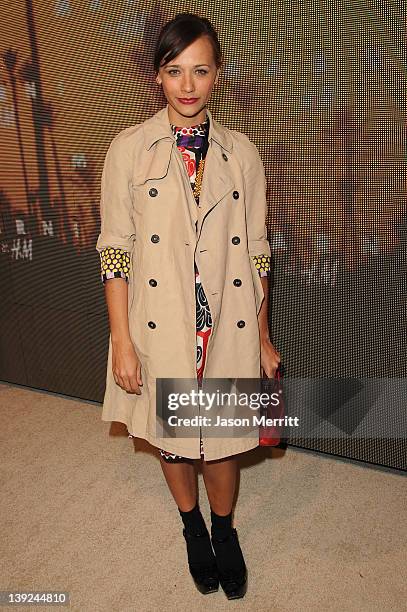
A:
[[96, 13, 280, 599]]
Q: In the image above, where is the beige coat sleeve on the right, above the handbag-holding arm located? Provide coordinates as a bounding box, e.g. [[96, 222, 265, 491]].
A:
[[243, 136, 271, 257]]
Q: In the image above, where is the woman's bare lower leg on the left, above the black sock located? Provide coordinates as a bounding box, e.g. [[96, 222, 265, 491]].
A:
[[160, 455, 198, 512]]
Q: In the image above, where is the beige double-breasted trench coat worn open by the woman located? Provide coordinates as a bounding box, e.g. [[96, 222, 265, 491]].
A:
[[96, 105, 270, 460]]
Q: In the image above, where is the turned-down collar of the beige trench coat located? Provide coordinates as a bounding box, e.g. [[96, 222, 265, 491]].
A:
[[143, 104, 233, 152]]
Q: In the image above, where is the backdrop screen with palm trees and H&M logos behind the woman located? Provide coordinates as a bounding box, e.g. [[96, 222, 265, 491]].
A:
[[0, 0, 407, 469]]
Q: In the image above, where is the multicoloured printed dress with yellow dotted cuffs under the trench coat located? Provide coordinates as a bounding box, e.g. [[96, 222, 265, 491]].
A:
[[100, 117, 270, 463]]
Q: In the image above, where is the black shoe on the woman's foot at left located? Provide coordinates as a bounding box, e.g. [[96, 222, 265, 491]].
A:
[[182, 529, 219, 595]]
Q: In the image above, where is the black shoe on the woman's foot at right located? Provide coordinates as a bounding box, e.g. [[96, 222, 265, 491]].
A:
[[211, 527, 247, 599]]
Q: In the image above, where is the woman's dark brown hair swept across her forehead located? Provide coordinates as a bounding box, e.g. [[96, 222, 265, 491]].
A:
[[154, 13, 223, 73]]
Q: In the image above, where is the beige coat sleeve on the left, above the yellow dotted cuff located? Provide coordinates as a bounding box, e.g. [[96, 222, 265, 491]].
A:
[[96, 133, 136, 253]]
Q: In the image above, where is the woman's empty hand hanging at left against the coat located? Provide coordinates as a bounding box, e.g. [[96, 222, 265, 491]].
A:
[[112, 340, 143, 395]]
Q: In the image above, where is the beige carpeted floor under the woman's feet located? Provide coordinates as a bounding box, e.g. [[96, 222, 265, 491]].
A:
[[0, 384, 407, 612]]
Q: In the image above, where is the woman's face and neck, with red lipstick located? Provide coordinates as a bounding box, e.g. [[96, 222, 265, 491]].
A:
[[156, 36, 219, 127]]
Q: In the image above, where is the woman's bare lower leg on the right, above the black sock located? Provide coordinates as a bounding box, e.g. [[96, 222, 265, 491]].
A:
[[201, 455, 238, 516]]
